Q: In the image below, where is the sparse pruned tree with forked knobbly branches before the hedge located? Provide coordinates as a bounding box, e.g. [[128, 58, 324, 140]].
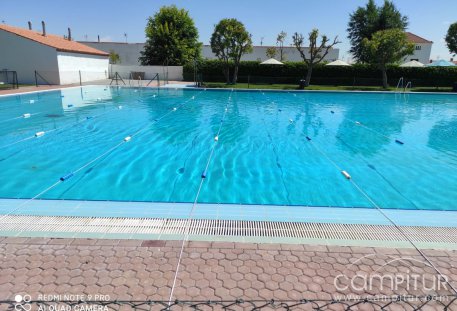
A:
[[292, 29, 341, 86]]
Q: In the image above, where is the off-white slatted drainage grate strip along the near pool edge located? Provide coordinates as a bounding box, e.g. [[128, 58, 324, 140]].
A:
[[0, 215, 457, 243]]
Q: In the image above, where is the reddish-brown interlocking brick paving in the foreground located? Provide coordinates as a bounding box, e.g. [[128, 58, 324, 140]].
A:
[[0, 237, 457, 310]]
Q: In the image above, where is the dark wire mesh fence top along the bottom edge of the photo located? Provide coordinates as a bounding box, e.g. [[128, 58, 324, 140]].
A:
[[0, 295, 457, 311]]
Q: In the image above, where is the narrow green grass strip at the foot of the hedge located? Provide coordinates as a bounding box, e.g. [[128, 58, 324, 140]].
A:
[[204, 82, 452, 92]]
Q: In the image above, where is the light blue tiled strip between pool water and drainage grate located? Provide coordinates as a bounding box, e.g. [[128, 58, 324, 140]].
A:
[[0, 199, 457, 228]]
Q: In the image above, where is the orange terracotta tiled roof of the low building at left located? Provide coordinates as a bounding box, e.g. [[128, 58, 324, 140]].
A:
[[0, 24, 109, 56]]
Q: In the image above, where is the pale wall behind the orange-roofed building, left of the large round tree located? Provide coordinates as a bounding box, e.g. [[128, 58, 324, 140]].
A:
[[79, 41, 144, 65]]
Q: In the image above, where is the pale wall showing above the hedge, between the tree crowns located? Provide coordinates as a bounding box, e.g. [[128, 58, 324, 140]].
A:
[[202, 45, 340, 62]]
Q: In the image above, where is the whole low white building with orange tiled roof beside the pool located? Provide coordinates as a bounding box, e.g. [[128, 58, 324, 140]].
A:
[[0, 23, 109, 84]]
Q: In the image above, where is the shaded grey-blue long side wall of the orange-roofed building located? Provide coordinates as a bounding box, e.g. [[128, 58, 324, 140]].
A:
[[0, 30, 60, 84]]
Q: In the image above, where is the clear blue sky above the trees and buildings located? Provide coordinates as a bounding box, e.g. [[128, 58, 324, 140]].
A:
[[0, 0, 457, 59]]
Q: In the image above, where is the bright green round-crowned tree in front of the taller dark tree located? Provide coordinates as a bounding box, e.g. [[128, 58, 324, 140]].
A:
[[362, 29, 414, 89]]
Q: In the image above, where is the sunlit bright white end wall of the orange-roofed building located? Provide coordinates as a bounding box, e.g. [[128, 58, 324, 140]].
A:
[[57, 52, 109, 84]]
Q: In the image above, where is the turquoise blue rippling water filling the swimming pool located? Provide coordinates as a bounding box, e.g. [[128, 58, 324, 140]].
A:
[[0, 86, 457, 210]]
